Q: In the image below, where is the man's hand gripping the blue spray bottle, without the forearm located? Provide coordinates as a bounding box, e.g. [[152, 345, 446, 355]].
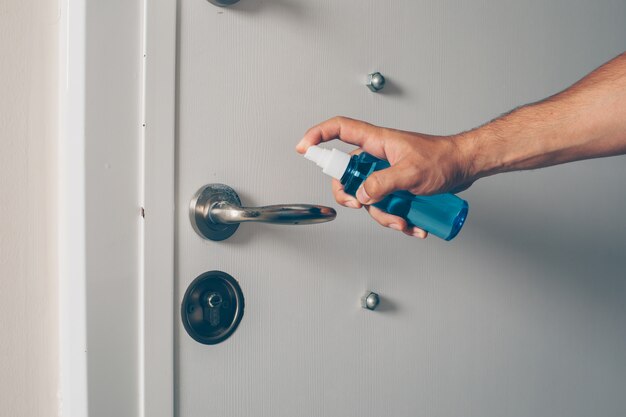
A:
[[296, 117, 473, 238]]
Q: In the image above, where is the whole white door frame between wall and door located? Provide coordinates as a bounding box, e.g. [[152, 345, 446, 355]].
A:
[[57, 0, 177, 417]]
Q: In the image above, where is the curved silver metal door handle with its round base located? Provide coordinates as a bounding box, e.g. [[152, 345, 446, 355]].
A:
[[189, 184, 337, 240]]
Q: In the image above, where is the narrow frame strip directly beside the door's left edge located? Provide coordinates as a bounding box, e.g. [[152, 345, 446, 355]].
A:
[[140, 0, 178, 417]]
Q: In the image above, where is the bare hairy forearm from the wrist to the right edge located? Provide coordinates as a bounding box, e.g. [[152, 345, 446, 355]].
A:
[[459, 53, 626, 179]]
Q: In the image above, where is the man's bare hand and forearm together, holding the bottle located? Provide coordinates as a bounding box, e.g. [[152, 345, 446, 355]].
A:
[[296, 52, 626, 238]]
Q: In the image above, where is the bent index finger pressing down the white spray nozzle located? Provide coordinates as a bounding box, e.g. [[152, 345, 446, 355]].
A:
[[296, 116, 385, 158]]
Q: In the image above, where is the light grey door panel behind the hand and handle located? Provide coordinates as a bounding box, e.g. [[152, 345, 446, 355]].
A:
[[175, 0, 626, 417]]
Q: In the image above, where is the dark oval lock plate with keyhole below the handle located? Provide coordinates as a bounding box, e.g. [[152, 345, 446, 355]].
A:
[[180, 271, 244, 345]]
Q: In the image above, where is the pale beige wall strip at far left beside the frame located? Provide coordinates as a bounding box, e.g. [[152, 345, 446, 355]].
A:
[[0, 0, 58, 417]]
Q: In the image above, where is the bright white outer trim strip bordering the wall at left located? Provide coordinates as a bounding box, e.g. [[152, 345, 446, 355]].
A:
[[57, 0, 88, 416]]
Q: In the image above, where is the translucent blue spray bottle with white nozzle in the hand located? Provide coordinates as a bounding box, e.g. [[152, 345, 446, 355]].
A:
[[304, 146, 469, 240]]
